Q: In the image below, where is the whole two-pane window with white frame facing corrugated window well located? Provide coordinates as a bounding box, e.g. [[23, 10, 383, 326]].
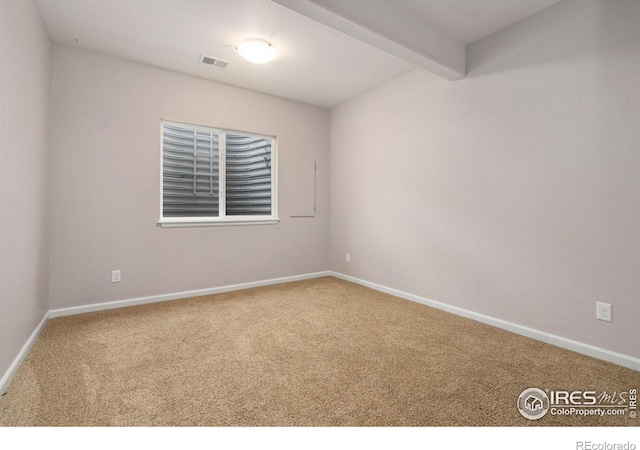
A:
[[159, 121, 278, 227]]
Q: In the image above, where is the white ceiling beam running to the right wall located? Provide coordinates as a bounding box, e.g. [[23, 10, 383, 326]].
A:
[[272, 0, 466, 80]]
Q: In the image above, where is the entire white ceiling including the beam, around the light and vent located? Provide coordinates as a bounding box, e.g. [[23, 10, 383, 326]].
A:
[[37, 0, 559, 108]]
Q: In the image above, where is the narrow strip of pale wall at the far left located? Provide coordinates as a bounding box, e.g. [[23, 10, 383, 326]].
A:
[[0, 0, 51, 378]]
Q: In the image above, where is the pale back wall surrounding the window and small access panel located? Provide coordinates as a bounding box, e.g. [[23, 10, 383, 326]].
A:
[[50, 45, 329, 309]]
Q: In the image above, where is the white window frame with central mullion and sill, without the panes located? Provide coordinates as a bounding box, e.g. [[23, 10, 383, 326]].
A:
[[158, 120, 280, 228]]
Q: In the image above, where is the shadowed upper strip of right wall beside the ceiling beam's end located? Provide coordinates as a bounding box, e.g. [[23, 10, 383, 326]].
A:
[[466, 0, 640, 78]]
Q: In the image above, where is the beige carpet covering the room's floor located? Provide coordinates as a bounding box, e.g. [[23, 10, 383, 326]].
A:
[[0, 278, 640, 426]]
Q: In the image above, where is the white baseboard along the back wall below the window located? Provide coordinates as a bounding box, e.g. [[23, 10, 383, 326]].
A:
[[49, 271, 331, 319]]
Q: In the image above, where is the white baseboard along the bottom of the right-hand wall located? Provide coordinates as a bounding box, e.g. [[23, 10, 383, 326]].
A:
[[330, 271, 640, 371]]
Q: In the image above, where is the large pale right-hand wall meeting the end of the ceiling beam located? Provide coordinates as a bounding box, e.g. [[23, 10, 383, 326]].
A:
[[330, 0, 640, 357]]
